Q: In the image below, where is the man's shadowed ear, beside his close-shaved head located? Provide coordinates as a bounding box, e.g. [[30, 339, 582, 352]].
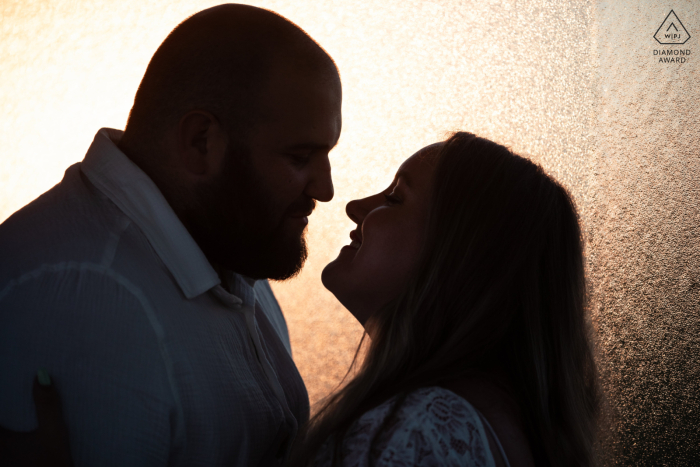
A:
[[177, 110, 228, 178]]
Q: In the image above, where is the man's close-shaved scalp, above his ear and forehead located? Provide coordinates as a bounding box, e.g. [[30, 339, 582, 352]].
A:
[[123, 4, 338, 155]]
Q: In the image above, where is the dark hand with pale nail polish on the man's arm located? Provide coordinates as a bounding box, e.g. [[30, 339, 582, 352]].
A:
[[0, 370, 73, 467]]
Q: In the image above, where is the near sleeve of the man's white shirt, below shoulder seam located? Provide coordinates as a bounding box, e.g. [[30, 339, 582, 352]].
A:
[[0, 264, 178, 467]]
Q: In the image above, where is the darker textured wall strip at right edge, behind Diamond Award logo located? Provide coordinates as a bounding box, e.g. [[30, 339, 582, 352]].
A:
[[586, 1, 700, 465]]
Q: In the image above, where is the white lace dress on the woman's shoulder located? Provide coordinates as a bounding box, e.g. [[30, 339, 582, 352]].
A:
[[314, 387, 508, 467]]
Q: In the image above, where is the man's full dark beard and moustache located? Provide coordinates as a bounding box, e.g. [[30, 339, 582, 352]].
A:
[[178, 147, 315, 281]]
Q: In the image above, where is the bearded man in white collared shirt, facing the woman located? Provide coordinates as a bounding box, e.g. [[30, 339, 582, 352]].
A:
[[0, 5, 341, 466]]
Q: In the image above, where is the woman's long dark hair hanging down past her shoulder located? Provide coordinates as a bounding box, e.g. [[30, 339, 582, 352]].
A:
[[292, 132, 598, 466]]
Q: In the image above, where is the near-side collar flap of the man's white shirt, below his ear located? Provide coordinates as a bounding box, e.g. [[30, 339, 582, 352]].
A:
[[81, 128, 221, 299]]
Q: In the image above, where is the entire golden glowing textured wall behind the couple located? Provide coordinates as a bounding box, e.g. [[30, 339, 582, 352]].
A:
[[0, 0, 700, 465]]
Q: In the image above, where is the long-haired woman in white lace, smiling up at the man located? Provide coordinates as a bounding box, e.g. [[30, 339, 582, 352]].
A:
[[292, 133, 598, 467]]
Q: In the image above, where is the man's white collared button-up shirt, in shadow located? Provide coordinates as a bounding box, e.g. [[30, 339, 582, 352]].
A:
[[0, 128, 309, 467]]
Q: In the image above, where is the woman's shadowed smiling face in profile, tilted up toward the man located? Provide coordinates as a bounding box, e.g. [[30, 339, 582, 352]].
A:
[[321, 143, 439, 326]]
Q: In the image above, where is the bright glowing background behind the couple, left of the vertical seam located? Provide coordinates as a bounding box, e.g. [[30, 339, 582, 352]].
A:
[[0, 0, 590, 408]]
